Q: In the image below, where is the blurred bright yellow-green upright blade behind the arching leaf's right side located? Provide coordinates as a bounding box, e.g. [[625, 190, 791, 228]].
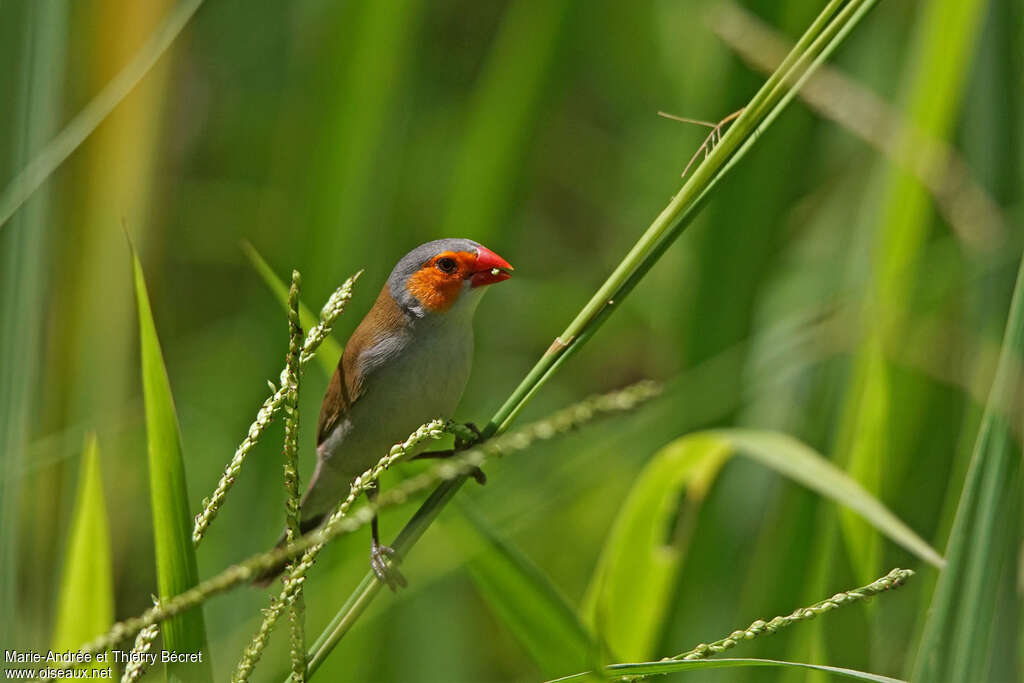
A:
[[839, 0, 985, 589]]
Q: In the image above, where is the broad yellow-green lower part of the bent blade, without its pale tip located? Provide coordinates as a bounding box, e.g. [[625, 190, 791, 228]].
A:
[[581, 434, 732, 660]]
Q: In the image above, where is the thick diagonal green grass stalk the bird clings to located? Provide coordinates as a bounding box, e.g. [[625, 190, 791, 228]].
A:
[[309, 0, 876, 673]]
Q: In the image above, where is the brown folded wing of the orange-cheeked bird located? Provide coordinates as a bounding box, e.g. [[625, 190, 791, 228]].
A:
[[316, 285, 402, 445]]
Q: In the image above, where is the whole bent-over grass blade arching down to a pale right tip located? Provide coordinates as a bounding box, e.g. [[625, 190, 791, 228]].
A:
[[583, 429, 942, 658]]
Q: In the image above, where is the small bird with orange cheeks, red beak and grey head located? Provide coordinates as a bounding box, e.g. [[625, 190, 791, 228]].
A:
[[254, 238, 513, 591]]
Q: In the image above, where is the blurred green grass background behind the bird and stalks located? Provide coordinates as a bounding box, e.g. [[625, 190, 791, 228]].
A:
[[0, 0, 1024, 681]]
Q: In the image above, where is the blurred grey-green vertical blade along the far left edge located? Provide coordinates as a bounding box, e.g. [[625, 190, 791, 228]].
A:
[[0, 2, 65, 646]]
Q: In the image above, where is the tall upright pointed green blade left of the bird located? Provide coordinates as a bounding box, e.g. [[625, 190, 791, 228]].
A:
[[132, 250, 212, 681]]
